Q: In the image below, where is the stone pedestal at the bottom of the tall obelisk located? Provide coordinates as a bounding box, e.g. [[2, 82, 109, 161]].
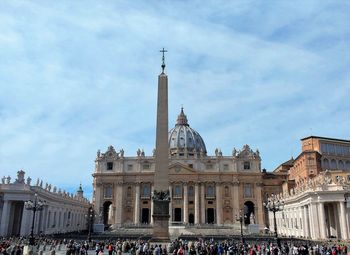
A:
[[151, 200, 170, 242]]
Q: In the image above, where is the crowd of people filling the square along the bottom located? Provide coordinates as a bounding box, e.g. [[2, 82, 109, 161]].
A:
[[0, 238, 350, 255]]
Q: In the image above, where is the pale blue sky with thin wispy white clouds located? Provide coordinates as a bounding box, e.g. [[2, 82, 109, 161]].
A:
[[0, 0, 350, 199]]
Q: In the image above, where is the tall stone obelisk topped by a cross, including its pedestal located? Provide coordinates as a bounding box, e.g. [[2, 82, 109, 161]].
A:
[[152, 48, 170, 242]]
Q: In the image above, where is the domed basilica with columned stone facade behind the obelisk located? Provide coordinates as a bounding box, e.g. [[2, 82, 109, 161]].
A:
[[93, 109, 286, 229]]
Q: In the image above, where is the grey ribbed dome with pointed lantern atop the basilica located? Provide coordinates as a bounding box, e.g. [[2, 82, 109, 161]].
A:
[[168, 108, 207, 156]]
